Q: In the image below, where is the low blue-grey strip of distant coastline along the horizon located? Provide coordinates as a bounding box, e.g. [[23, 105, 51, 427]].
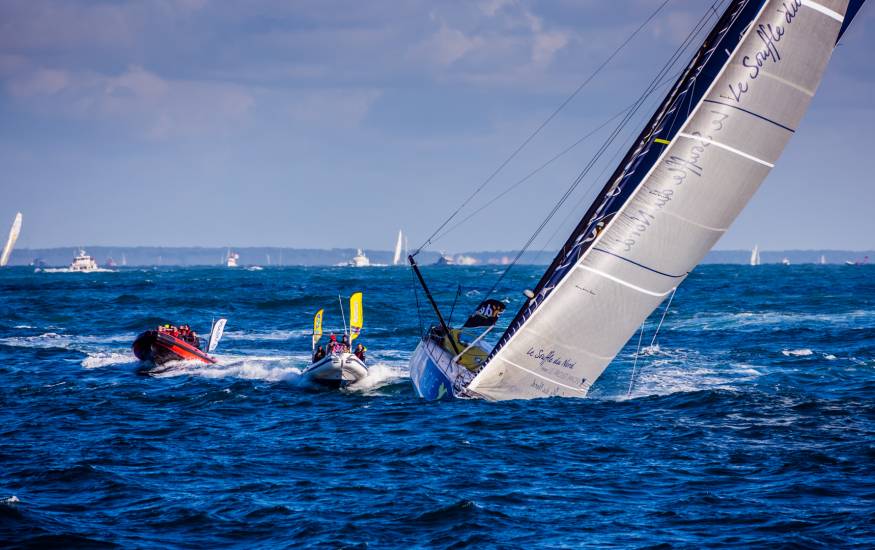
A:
[[9, 246, 875, 266]]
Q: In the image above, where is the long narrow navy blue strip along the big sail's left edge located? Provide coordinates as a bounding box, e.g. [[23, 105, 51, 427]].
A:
[[484, 0, 766, 364]]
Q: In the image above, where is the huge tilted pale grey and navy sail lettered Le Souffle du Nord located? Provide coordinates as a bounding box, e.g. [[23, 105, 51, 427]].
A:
[[468, 0, 862, 399]]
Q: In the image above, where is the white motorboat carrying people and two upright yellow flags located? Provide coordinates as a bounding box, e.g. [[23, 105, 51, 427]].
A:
[[301, 292, 368, 389]]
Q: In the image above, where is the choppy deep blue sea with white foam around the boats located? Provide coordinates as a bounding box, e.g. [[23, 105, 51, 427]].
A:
[[0, 266, 875, 548]]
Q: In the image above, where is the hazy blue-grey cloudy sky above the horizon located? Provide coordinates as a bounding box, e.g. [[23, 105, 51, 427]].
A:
[[0, 0, 875, 252]]
